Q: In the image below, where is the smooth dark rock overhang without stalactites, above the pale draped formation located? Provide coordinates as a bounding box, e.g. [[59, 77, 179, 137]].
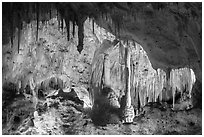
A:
[[97, 2, 202, 81]]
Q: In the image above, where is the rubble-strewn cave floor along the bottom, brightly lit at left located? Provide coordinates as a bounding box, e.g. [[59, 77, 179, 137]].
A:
[[3, 89, 202, 135]]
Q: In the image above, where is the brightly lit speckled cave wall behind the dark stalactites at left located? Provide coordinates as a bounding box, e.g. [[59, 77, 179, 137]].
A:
[[2, 15, 114, 94]]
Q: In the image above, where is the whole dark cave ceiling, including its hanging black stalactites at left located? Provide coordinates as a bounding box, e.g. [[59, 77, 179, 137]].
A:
[[2, 2, 202, 80]]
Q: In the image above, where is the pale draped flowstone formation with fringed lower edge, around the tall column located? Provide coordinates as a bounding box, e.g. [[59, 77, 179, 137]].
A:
[[90, 40, 196, 114]]
